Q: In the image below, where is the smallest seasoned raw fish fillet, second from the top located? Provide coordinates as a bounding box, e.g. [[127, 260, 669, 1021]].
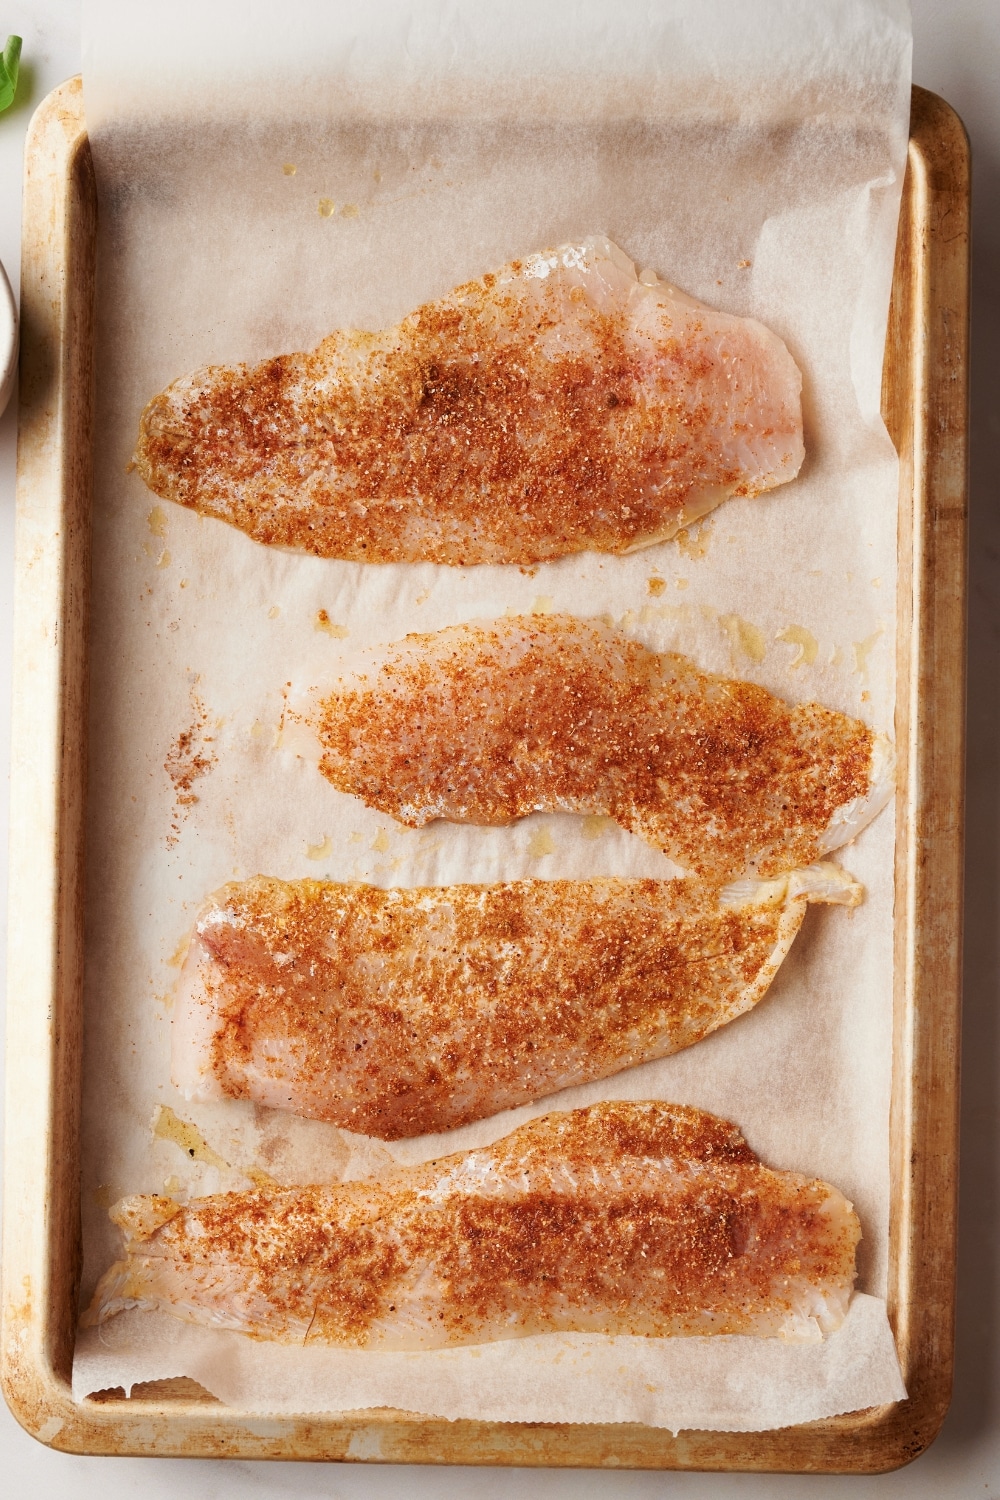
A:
[[310, 615, 892, 882]]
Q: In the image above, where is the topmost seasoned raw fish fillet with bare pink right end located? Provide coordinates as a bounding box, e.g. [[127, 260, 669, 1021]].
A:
[[135, 237, 804, 564]]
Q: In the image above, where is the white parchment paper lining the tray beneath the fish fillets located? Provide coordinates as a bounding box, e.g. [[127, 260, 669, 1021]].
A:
[[73, 0, 910, 1430]]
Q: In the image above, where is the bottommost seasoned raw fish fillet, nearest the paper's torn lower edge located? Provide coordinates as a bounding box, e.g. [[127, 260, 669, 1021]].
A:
[[84, 1103, 861, 1349]]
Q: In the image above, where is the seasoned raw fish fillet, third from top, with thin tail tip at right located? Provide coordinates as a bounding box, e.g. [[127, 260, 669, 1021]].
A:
[[172, 864, 862, 1140]]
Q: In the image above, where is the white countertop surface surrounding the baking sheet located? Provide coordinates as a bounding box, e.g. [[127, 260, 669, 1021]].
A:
[[0, 0, 1000, 1500]]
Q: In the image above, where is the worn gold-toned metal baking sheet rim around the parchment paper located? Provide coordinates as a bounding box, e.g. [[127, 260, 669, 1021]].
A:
[[3, 80, 969, 1472]]
